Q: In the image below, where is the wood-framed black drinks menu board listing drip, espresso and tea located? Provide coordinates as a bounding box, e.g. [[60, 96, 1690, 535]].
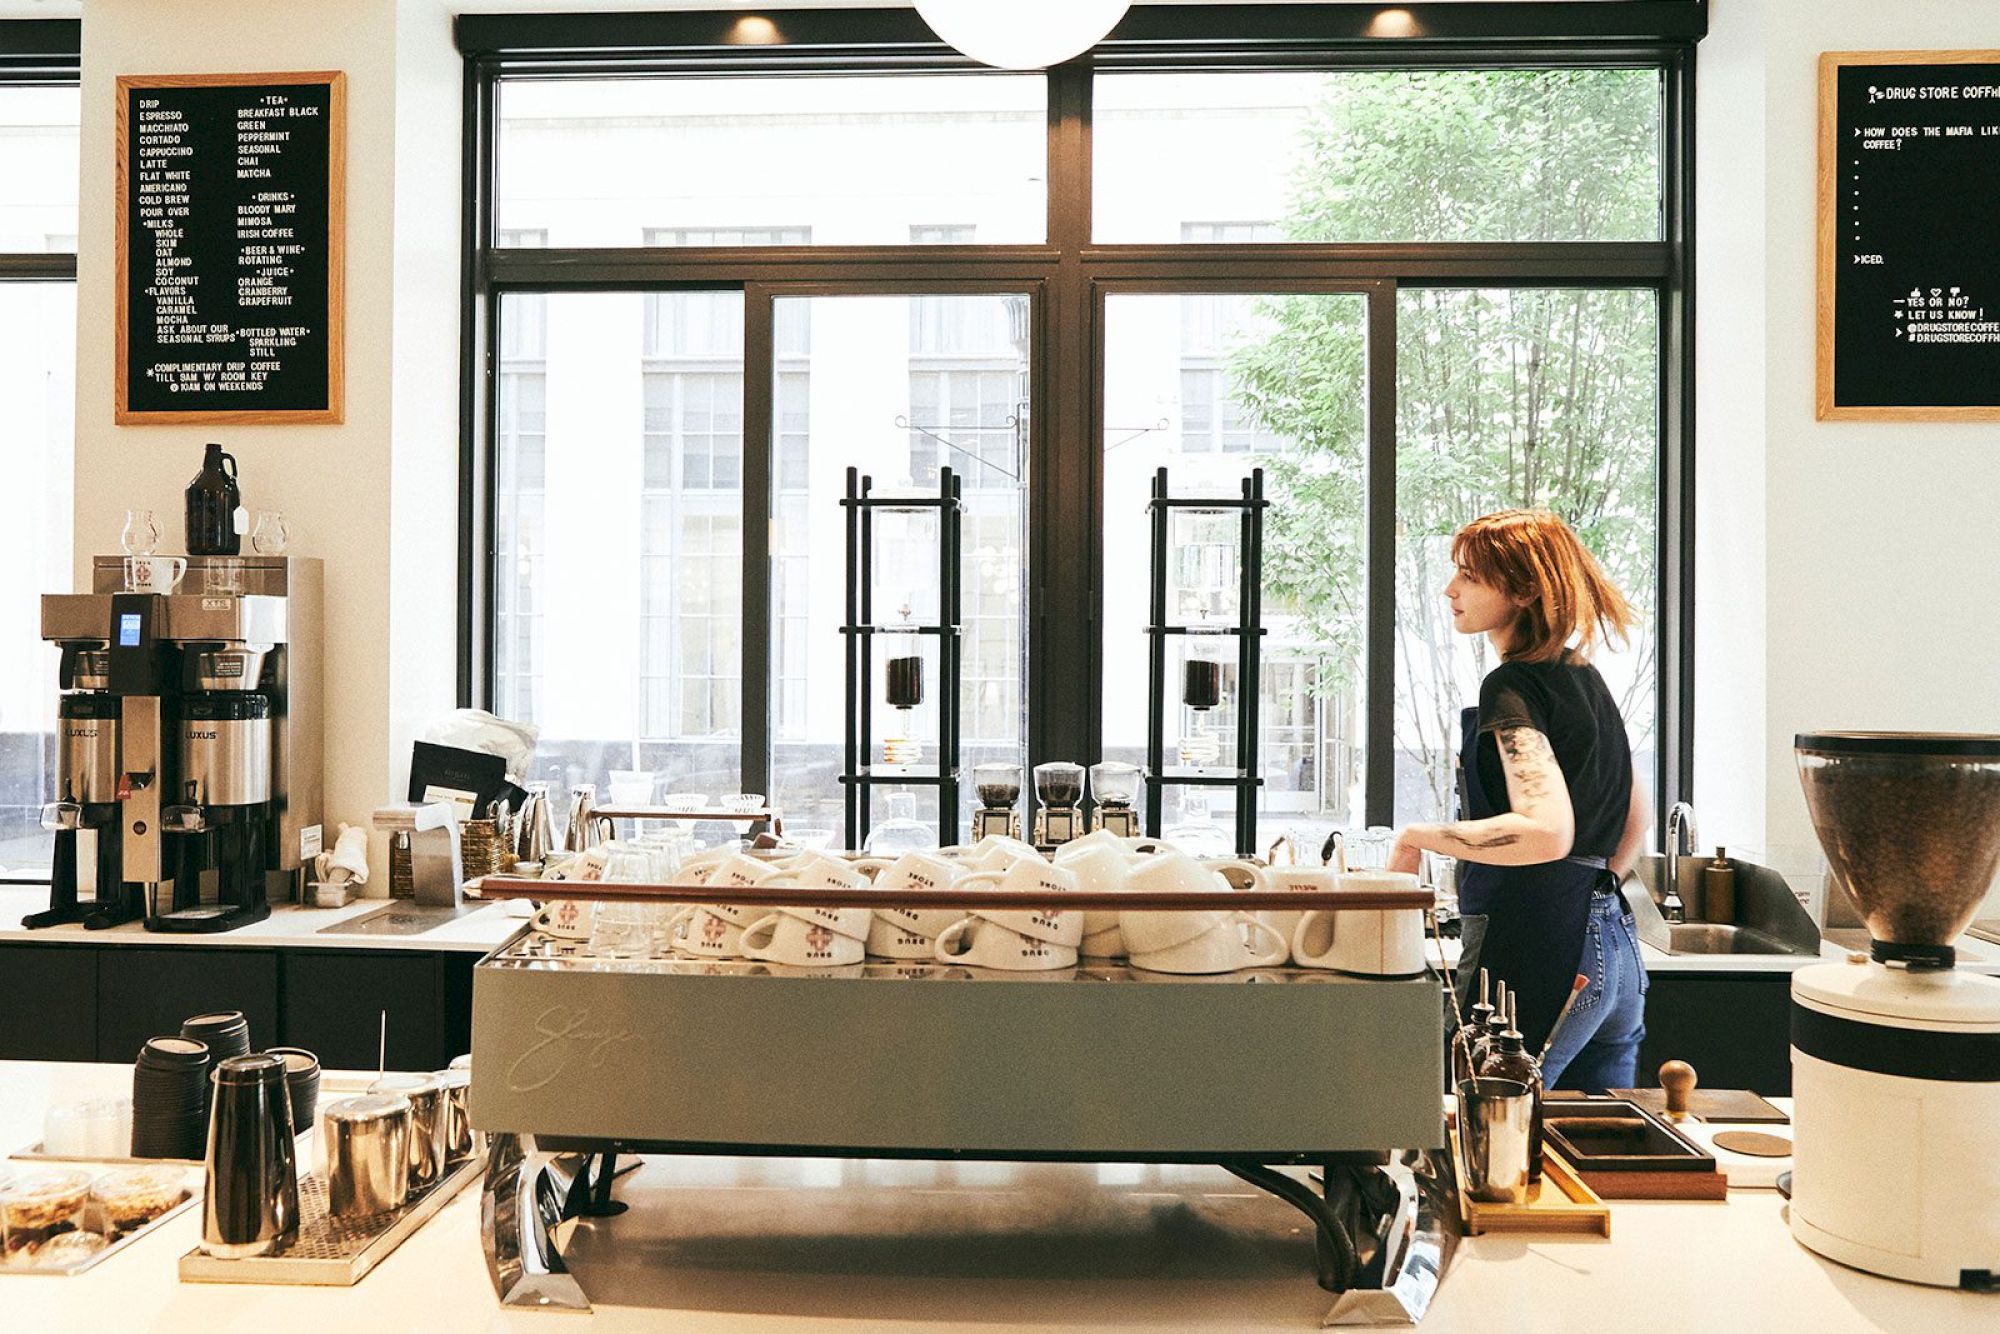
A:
[[116, 74, 346, 424]]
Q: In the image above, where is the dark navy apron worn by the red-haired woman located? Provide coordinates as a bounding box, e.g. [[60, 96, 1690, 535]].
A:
[[1456, 708, 1616, 1052]]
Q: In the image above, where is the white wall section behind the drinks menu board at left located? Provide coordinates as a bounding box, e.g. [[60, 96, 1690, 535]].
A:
[[74, 0, 462, 892]]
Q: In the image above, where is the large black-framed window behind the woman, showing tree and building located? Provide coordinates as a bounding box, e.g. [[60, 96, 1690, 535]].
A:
[[462, 6, 1690, 844]]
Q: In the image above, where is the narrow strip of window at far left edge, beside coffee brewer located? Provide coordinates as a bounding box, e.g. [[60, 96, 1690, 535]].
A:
[[0, 83, 79, 876]]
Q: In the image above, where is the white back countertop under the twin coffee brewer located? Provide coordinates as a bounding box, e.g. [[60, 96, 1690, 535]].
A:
[[0, 884, 522, 954]]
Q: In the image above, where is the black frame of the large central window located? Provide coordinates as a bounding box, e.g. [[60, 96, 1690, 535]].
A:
[[456, 0, 1708, 840]]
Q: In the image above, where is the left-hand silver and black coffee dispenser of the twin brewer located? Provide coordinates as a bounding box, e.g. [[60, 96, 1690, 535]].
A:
[[22, 644, 140, 930]]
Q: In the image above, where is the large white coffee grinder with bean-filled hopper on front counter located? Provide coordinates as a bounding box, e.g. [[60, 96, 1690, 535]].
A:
[[1790, 732, 2000, 1292]]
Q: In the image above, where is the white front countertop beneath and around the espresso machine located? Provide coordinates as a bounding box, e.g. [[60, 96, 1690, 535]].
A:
[[0, 1062, 2000, 1334]]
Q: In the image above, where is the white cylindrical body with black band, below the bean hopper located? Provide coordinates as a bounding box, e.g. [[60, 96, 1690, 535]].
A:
[[1790, 956, 2000, 1288]]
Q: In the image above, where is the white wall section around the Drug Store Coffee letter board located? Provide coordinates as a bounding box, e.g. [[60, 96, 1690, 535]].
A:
[[1696, 0, 2000, 920]]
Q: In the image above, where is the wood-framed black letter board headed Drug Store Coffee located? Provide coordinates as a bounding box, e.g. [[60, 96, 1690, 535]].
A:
[[1818, 50, 2000, 420]]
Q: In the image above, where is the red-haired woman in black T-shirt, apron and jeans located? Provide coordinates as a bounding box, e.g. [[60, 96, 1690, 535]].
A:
[[1390, 510, 1648, 1088]]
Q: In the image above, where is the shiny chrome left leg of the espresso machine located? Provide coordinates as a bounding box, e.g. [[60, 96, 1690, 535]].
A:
[[480, 1134, 590, 1312]]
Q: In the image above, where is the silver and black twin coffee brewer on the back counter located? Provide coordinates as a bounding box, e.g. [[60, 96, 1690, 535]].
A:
[[42, 556, 322, 932]]
